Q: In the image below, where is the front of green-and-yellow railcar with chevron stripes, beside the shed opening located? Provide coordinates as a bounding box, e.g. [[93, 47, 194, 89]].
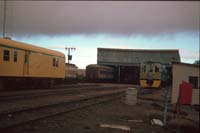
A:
[[140, 62, 162, 88]]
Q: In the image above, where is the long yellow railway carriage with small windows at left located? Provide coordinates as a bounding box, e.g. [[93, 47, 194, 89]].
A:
[[0, 39, 65, 88]]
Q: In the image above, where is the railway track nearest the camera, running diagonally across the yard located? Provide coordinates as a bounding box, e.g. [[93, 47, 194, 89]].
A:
[[0, 89, 125, 131]]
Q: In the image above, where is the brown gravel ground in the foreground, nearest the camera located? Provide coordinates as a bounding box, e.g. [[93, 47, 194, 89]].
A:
[[0, 85, 199, 133]]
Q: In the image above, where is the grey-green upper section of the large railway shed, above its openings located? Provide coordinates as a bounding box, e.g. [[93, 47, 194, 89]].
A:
[[97, 48, 180, 66]]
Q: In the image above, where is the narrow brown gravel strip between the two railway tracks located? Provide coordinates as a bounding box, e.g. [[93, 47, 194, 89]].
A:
[[0, 88, 126, 113]]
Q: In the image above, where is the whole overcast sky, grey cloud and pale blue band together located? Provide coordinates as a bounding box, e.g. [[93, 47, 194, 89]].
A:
[[0, 1, 200, 68]]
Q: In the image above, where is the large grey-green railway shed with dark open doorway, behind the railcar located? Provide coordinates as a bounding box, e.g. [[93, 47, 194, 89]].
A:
[[97, 48, 180, 84]]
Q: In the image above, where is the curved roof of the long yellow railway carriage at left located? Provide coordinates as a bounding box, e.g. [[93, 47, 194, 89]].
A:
[[0, 38, 65, 58]]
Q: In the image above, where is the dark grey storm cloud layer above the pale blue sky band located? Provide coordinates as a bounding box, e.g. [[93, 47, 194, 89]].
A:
[[0, 1, 200, 35]]
